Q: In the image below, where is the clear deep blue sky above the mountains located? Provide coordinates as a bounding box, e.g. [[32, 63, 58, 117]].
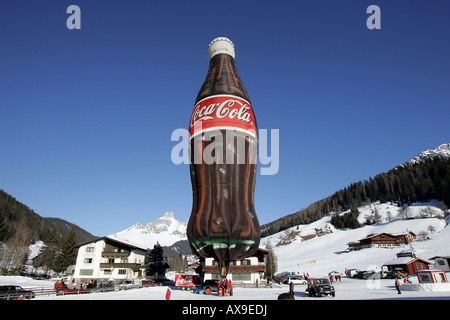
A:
[[0, 0, 450, 236]]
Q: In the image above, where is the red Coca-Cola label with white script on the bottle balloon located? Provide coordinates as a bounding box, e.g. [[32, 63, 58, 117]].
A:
[[189, 95, 256, 138]]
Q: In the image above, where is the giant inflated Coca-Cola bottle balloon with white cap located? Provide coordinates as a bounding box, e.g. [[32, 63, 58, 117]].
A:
[[187, 37, 261, 277]]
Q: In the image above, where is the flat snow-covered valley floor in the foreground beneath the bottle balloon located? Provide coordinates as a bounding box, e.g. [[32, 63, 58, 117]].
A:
[[0, 276, 450, 301]]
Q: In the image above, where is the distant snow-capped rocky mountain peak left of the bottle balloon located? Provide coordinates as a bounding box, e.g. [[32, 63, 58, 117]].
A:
[[108, 212, 187, 249]]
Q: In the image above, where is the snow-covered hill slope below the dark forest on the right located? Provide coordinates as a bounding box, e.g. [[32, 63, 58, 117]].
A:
[[261, 201, 450, 277]]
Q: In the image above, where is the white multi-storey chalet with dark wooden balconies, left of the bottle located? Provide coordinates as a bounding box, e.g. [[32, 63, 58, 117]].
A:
[[73, 237, 148, 281]]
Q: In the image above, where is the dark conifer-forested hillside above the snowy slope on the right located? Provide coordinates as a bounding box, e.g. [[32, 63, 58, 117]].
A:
[[262, 157, 450, 237]]
